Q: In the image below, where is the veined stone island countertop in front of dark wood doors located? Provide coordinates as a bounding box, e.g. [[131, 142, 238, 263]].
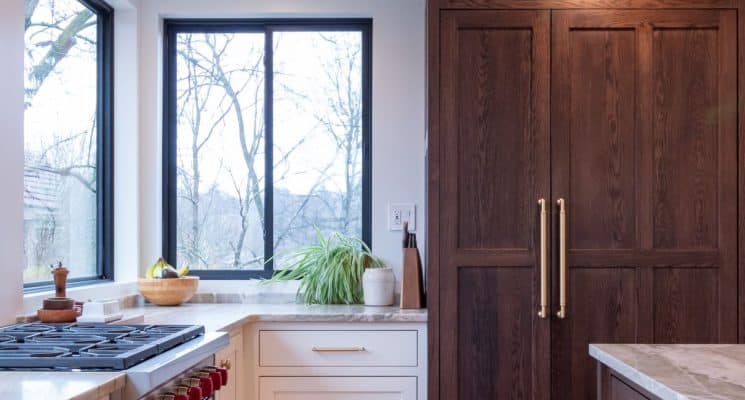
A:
[[590, 344, 745, 400]]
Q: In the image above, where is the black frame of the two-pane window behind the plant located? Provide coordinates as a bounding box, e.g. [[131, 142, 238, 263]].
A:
[[162, 18, 373, 280]]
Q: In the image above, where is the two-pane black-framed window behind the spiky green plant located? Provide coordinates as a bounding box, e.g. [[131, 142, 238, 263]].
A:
[[163, 19, 372, 279]]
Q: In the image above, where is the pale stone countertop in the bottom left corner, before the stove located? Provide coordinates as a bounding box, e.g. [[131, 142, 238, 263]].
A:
[[0, 371, 126, 400]]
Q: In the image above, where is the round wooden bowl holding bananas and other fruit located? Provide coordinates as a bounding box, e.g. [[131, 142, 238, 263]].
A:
[[138, 257, 199, 306]]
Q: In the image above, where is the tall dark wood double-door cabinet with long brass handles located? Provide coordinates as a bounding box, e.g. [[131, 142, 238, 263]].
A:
[[428, 0, 743, 400]]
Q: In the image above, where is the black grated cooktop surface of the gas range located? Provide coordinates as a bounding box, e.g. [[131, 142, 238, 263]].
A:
[[0, 323, 204, 371]]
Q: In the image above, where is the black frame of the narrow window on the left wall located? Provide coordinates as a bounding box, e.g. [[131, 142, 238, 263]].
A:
[[23, 0, 114, 293]]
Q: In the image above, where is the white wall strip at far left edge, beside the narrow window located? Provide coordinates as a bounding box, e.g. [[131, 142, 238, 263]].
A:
[[0, 0, 24, 323]]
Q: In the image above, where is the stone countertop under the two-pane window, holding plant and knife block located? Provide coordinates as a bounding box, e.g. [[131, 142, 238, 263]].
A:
[[119, 303, 427, 331]]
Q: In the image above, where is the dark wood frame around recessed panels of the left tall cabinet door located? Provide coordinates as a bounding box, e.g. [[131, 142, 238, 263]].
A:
[[436, 10, 551, 399]]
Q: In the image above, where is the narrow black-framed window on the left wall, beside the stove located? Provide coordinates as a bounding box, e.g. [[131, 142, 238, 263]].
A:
[[23, 0, 113, 289]]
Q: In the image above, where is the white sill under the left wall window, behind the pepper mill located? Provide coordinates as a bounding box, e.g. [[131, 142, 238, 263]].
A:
[[21, 281, 137, 315]]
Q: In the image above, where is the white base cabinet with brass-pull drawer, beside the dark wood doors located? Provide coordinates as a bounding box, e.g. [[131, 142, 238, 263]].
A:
[[247, 321, 427, 400]]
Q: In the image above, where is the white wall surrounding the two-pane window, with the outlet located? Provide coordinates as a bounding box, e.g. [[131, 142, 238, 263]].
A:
[[139, 0, 426, 288]]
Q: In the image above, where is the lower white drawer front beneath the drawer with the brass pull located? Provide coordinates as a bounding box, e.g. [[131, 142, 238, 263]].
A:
[[259, 376, 417, 400]]
